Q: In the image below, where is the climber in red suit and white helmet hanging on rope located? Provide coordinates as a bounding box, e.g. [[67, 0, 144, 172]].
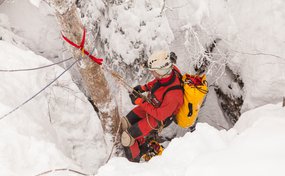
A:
[[121, 51, 183, 162]]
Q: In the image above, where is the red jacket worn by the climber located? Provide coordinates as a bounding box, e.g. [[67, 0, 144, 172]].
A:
[[139, 67, 183, 121]]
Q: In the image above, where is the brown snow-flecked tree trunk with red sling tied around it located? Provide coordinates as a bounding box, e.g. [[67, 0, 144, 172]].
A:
[[45, 0, 120, 140]]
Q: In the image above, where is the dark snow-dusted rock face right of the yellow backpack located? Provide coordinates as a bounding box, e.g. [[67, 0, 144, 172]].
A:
[[194, 38, 244, 129]]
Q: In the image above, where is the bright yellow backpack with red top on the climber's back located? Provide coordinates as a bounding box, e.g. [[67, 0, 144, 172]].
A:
[[176, 73, 208, 128]]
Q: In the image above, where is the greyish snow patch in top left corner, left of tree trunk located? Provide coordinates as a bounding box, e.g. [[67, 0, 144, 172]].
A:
[[0, 0, 63, 60]]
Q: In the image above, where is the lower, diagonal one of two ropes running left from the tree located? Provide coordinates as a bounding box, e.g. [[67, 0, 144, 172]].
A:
[[0, 58, 82, 120]]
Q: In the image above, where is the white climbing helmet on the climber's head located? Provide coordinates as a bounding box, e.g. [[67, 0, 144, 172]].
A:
[[147, 50, 173, 76]]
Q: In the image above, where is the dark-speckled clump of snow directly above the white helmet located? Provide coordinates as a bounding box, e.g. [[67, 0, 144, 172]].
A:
[[101, 1, 173, 64]]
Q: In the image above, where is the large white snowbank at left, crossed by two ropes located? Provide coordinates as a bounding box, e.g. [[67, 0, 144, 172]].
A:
[[0, 41, 105, 175]]
